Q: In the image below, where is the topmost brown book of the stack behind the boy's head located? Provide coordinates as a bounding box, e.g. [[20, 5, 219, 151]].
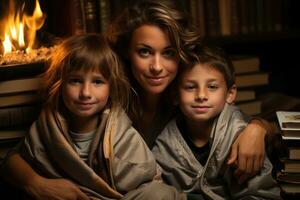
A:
[[230, 55, 260, 74]]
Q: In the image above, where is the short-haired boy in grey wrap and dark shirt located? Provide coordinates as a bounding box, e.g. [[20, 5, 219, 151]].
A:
[[153, 47, 280, 199]]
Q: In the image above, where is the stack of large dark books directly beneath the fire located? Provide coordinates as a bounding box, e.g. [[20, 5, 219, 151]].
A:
[[0, 63, 44, 160]]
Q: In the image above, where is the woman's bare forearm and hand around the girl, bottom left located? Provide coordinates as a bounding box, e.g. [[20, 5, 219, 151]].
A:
[[1, 153, 89, 200]]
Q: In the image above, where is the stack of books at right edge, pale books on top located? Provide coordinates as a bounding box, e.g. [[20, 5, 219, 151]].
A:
[[276, 111, 300, 199]]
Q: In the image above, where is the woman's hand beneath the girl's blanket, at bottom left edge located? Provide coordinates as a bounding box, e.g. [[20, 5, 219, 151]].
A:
[[25, 176, 89, 200]]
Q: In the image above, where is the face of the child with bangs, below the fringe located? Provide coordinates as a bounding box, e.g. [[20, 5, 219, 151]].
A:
[[62, 70, 109, 123]]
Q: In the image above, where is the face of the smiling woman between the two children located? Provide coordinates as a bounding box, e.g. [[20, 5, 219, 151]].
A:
[[129, 25, 179, 94]]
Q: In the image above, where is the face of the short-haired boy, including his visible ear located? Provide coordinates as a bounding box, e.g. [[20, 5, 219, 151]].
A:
[[179, 64, 236, 122]]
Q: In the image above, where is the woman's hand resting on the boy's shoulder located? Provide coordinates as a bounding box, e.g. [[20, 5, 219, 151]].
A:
[[227, 119, 267, 183]]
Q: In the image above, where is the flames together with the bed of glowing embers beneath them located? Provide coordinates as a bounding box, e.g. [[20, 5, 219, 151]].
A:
[[0, 0, 52, 65]]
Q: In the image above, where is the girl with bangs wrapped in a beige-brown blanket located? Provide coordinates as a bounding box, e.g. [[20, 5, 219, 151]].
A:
[[1, 34, 184, 199]]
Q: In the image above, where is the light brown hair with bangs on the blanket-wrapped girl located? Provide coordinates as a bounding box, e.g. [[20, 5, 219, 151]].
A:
[[43, 34, 130, 113]]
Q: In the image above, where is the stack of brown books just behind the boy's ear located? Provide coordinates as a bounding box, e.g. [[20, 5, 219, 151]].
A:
[[231, 55, 269, 115]]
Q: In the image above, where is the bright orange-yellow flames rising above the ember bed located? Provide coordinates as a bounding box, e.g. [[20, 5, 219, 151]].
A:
[[0, 0, 46, 55]]
